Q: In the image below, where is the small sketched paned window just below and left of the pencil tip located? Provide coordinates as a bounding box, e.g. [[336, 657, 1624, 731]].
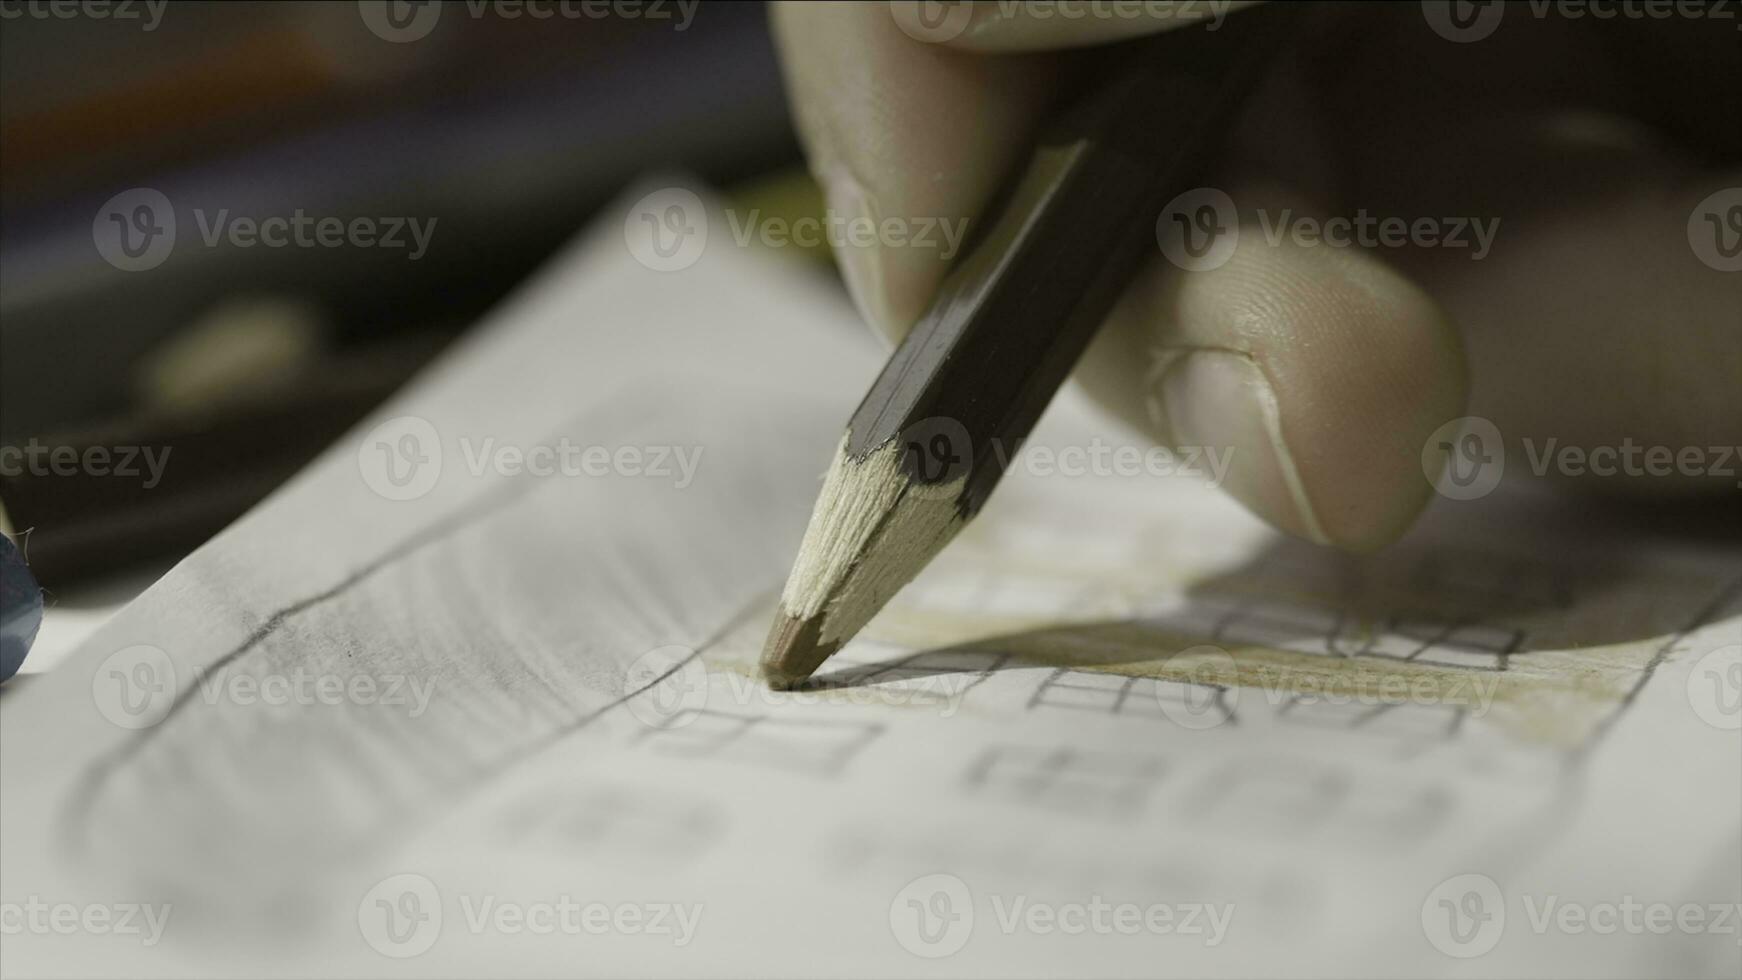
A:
[[636, 708, 883, 776]]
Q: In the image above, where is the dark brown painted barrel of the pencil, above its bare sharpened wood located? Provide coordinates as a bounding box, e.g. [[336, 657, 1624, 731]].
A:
[[847, 3, 1298, 517]]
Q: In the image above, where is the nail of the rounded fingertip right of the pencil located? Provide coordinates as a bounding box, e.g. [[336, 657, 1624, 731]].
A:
[[1150, 350, 1331, 545]]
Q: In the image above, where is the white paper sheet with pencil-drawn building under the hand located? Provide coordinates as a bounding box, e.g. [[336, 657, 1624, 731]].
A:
[[0, 187, 1742, 977]]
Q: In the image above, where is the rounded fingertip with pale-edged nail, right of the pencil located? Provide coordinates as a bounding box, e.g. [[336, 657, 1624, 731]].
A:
[[1078, 181, 1467, 550]]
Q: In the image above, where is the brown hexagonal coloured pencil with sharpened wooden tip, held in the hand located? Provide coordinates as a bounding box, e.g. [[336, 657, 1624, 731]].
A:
[[761, 3, 1293, 688]]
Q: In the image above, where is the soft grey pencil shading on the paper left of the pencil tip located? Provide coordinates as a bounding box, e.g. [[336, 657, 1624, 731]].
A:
[[57, 379, 832, 928]]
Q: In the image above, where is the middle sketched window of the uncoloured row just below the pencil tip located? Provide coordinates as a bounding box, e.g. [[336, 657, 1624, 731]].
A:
[[965, 745, 1165, 816]]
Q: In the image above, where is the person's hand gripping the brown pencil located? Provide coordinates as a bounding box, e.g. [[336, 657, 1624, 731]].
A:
[[773, 2, 1742, 550]]
